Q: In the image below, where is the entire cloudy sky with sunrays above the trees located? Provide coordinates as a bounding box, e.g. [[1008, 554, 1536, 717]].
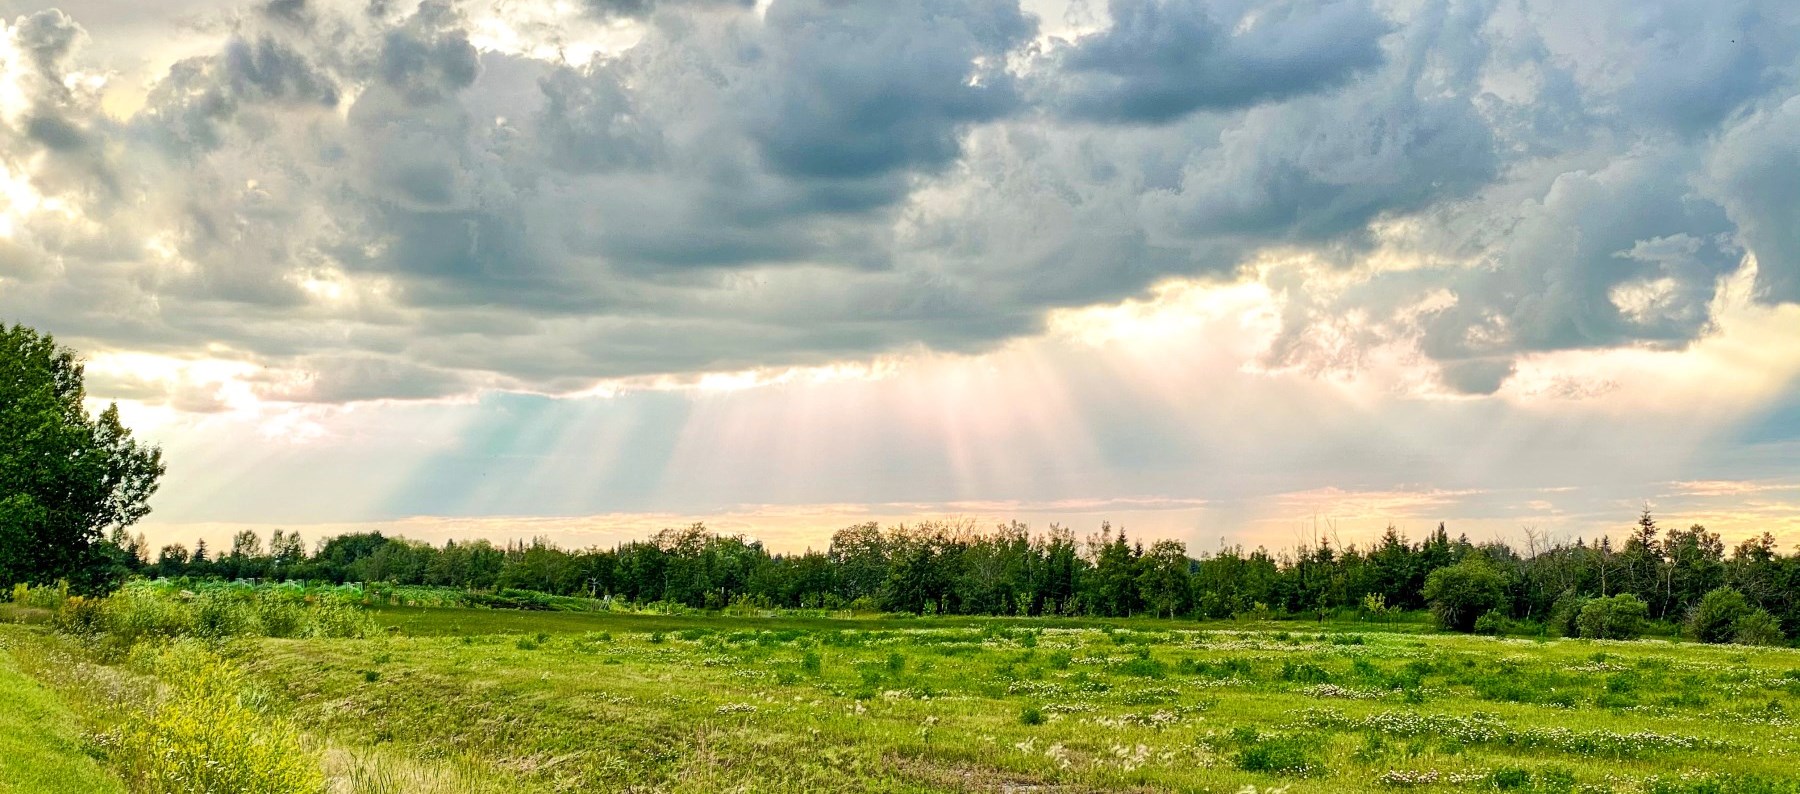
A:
[[0, 0, 1800, 553]]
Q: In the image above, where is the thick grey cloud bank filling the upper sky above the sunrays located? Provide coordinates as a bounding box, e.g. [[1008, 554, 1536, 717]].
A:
[[0, 0, 1800, 402]]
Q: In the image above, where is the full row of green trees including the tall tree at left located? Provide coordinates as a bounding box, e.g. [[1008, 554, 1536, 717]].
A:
[[0, 326, 1800, 639]]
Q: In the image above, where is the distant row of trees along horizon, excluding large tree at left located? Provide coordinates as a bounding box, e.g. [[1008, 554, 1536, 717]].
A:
[[108, 511, 1800, 636]]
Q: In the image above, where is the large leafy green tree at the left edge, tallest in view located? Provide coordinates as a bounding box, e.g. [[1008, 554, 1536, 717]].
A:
[[0, 326, 164, 591]]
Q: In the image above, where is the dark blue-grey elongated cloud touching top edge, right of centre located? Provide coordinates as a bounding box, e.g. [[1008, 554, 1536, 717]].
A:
[[1044, 0, 1390, 124]]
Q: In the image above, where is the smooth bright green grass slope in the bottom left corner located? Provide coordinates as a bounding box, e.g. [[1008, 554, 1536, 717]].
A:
[[0, 633, 124, 794]]
